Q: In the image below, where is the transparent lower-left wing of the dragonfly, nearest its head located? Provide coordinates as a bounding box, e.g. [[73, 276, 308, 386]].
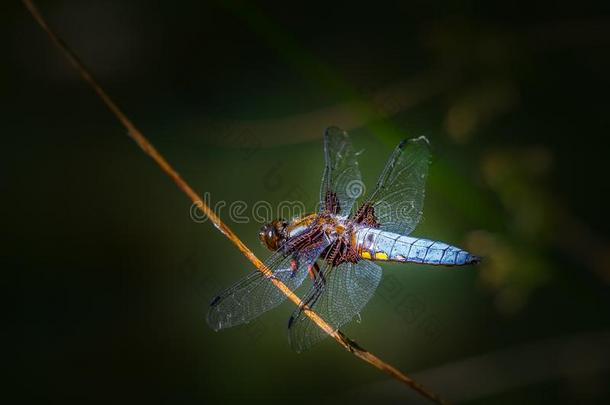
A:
[[207, 244, 327, 330]]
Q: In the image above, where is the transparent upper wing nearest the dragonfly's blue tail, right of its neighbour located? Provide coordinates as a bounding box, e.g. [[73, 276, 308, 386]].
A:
[[365, 136, 430, 235]]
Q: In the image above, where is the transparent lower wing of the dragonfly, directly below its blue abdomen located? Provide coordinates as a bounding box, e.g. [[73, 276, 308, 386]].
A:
[[288, 260, 381, 352]]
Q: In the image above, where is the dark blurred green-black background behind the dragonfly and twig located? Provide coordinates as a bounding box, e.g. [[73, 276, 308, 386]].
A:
[[0, 1, 610, 404]]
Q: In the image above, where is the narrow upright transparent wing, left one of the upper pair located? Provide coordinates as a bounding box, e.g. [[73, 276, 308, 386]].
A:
[[320, 127, 364, 215]]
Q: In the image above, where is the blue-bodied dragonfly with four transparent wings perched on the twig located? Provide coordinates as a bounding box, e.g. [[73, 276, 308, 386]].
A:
[[207, 127, 480, 352]]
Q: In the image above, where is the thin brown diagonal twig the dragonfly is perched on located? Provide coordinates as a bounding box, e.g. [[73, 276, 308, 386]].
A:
[[22, 0, 446, 404]]
